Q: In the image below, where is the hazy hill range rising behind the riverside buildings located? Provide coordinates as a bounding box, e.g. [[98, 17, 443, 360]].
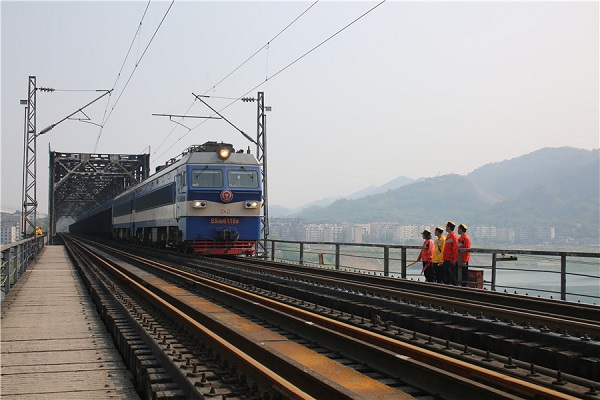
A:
[[293, 147, 600, 237]]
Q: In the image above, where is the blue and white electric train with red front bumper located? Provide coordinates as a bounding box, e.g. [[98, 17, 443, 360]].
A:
[[69, 142, 263, 256]]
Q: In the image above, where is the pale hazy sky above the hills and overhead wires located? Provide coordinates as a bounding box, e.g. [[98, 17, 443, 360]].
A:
[[1, 1, 600, 213]]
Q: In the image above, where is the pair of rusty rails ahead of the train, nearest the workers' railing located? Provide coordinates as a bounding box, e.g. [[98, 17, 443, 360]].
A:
[[211, 259, 600, 334]]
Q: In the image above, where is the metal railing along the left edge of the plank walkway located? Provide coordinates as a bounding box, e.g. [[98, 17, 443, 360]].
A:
[[0, 235, 46, 301]]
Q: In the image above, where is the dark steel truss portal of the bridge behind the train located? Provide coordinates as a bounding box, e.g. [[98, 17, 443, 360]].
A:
[[48, 151, 150, 244]]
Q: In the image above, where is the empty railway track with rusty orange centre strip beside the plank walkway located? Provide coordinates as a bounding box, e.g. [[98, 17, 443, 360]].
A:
[[63, 236, 596, 399]]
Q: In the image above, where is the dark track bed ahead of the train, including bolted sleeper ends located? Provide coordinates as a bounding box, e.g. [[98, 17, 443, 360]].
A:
[[192, 255, 600, 385]]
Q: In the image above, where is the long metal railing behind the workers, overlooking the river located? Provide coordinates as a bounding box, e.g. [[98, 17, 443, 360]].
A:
[[268, 239, 600, 304]]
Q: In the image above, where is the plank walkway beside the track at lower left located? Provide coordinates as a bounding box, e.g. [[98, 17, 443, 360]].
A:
[[0, 246, 139, 400]]
